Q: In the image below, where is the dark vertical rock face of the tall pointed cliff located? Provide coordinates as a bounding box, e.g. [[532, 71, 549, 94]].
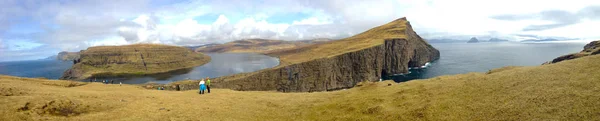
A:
[[212, 20, 440, 92]]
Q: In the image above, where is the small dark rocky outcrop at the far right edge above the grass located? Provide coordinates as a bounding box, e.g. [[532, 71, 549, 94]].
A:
[[544, 40, 600, 64]]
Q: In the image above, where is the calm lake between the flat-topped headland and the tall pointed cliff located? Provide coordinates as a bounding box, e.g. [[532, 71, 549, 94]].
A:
[[89, 53, 279, 84]]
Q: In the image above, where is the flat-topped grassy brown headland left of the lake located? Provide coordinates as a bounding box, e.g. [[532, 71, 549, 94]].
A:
[[61, 44, 210, 80]]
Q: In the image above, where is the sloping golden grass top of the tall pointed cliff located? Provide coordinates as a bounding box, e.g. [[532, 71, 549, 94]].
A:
[[269, 17, 410, 64]]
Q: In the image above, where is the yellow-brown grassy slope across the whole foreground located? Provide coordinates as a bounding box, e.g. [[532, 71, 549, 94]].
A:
[[0, 52, 600, 121]]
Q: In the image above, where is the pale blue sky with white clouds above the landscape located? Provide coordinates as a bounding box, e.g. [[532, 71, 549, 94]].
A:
[[0, 0, 600, 61]]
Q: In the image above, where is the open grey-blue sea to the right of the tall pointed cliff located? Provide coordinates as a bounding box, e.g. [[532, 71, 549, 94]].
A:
[[384, 42, 587, 82]]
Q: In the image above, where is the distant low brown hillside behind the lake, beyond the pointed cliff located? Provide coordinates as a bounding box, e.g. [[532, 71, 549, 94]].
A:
[[195, 39, 329, 53]]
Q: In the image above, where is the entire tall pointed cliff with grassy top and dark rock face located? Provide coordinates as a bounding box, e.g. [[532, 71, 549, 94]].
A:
[[213, 18, 440, 92]]
